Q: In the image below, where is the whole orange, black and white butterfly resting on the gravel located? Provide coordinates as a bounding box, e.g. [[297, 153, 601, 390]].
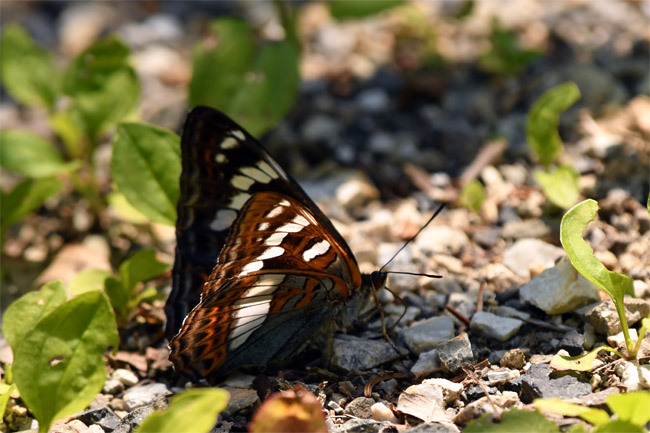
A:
[[165, 107, 386, 378]]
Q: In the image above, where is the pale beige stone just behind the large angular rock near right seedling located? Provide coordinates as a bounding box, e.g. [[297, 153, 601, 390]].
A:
[[503, 239, 565, 278]]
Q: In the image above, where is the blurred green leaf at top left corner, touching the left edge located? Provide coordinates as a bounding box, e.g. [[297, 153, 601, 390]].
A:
[[0, 24, 59, 110]]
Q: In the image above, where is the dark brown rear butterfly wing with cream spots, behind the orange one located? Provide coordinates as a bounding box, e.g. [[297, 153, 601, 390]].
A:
[[165, 107, 356, 340]]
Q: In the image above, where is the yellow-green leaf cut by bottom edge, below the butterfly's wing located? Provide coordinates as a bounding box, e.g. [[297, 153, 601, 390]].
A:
[[136, 388, 229, 433]]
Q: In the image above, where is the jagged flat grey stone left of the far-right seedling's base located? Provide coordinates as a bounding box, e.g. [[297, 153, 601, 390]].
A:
[[510, 364, 591, 404]]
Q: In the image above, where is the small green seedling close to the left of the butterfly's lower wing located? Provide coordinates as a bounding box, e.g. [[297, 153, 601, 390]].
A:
[[68, 249, 169, 327]]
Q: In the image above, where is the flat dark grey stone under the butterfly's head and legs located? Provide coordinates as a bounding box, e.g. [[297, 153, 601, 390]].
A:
[[332, 335, 397, 371]]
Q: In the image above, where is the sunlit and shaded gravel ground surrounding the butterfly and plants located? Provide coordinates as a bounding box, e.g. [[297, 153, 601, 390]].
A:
[[0, 0, 650, 433]]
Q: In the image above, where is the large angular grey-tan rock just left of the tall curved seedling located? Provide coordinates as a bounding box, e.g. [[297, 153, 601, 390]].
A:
[[519, 260, 600, 314]]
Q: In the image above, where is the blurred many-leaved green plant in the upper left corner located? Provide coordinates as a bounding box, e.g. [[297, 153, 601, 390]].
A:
[[0, 25, 140, 235]]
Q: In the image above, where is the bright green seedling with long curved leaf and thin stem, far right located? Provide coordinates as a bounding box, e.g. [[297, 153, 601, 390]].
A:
[[560, 199, 648, 359]]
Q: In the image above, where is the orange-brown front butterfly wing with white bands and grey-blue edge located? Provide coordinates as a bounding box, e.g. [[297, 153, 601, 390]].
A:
[[170, 192, 368, 376]]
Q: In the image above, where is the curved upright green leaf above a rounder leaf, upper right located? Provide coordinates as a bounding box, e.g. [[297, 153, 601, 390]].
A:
[[526, 82, 580, 167]]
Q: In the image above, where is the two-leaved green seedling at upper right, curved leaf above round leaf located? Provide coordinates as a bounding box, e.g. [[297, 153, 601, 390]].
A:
[[526, 82, 580, 209]]
